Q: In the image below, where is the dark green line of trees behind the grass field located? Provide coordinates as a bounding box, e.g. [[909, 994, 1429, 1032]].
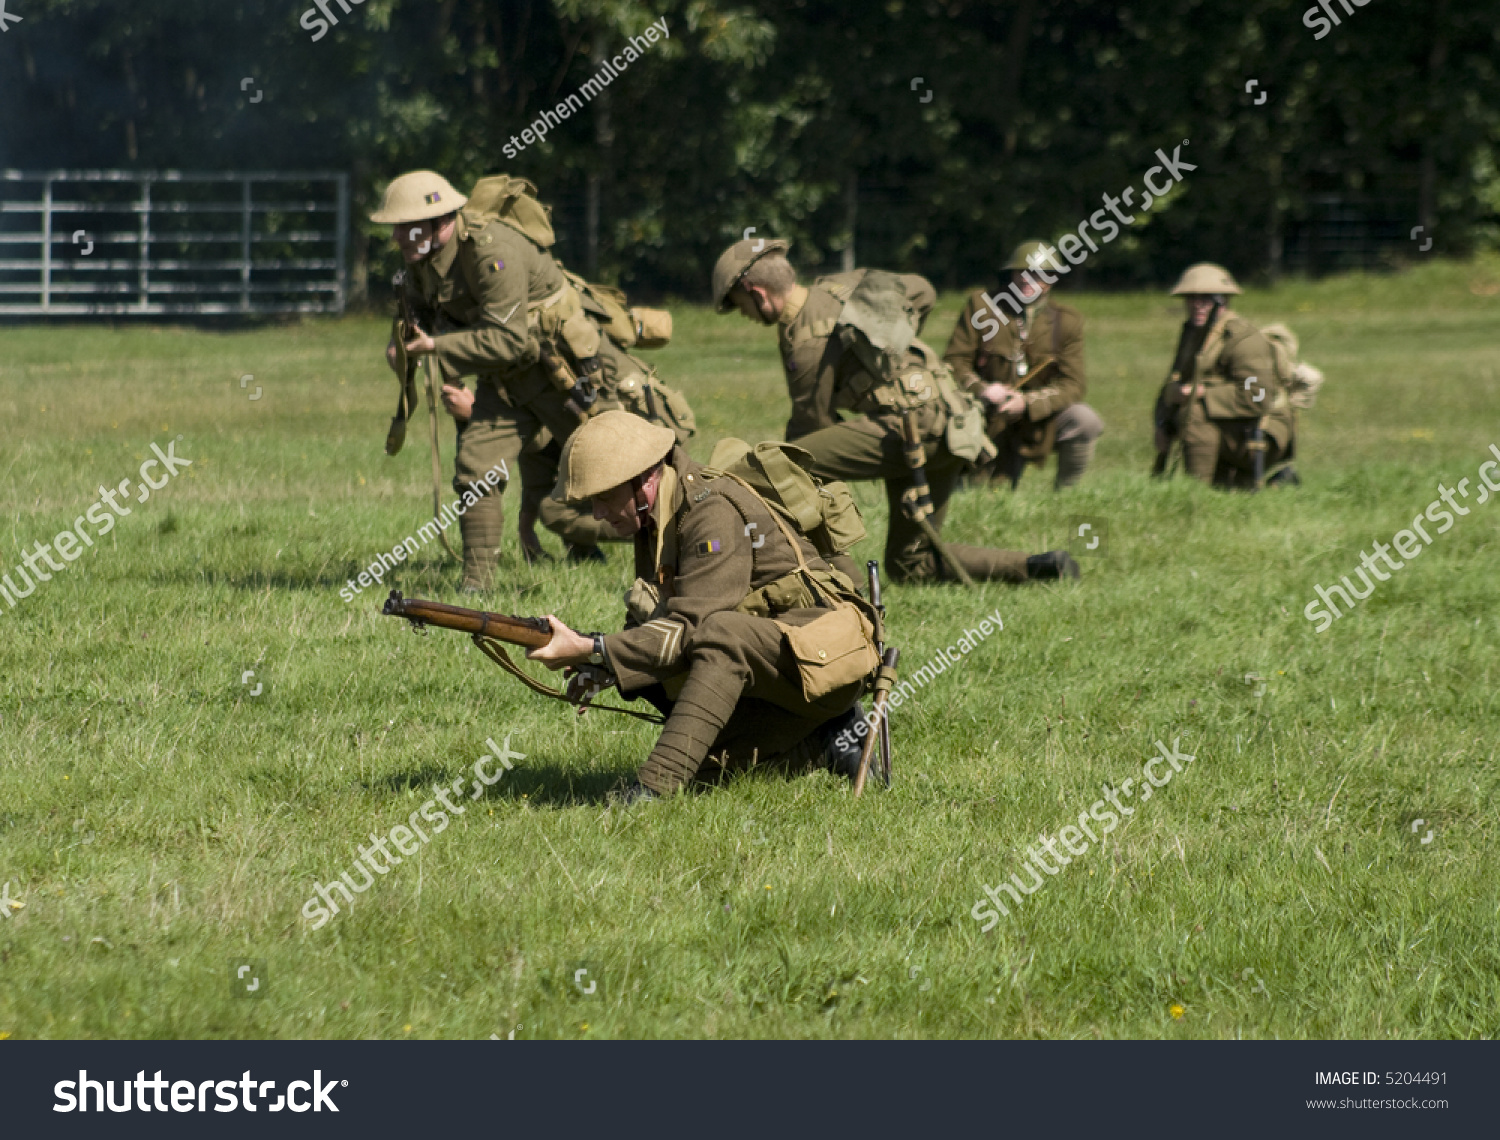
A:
[[0, 0, 1500, 300]]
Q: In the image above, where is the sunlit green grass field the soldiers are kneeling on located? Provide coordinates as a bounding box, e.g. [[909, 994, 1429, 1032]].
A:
[[0, 260, 1500, 1040]]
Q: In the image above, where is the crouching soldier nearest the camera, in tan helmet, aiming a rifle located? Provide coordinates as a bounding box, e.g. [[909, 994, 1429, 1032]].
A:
[[527, 411, 879, 803]]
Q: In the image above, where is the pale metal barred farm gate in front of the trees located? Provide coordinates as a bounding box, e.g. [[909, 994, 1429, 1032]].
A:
[[0, 170, 350, 317]]
